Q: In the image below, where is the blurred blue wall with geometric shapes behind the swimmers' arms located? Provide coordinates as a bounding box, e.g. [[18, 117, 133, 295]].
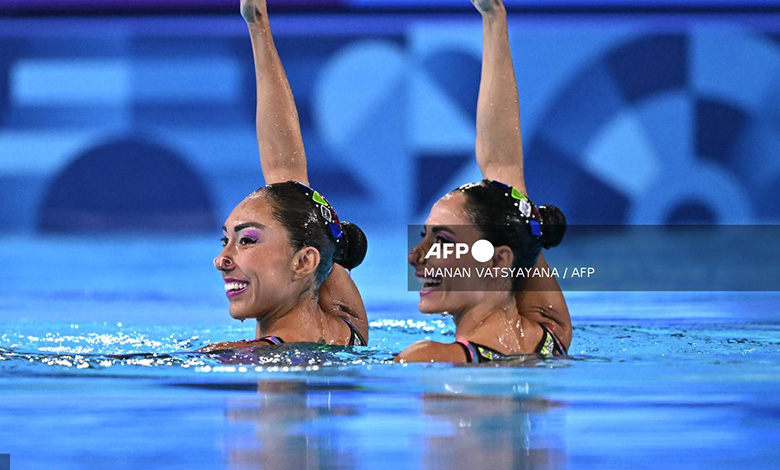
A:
[[0, 12, 780, 237]]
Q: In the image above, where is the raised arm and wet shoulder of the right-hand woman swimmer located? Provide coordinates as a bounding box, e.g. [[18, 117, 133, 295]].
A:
[[472, 0, 571, 347]]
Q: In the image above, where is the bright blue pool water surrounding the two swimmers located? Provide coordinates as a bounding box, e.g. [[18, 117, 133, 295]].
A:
[[0, 237, 780, 469]]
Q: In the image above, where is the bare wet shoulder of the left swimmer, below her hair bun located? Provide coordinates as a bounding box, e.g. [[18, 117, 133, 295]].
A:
[[319, 264, 368, 341]]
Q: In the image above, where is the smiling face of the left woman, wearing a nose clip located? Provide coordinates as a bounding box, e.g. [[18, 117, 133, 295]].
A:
[[214, 195, 311, 320]]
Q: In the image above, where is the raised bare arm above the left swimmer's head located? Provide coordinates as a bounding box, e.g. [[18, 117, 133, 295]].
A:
[[241, 0, 309, 184]]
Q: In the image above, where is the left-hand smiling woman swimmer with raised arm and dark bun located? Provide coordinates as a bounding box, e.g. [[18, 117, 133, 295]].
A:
[[200, 0, 368, 352]]
